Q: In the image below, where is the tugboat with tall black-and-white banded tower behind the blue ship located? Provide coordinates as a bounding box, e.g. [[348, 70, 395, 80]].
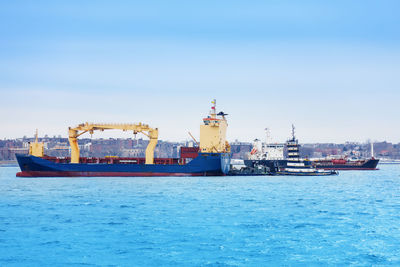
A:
[[276, 125, 338, 176]]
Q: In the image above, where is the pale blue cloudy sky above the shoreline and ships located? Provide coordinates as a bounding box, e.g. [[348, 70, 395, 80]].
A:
[[0, 0, 400, 143]]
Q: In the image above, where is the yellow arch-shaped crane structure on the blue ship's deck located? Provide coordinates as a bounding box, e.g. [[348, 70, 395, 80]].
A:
[[68, 122, 158, 164]]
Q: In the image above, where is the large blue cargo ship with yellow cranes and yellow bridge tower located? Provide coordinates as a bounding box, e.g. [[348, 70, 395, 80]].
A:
[[16, 100, 231, 177]]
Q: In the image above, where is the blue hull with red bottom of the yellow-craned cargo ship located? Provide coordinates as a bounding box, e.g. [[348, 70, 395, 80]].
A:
[[16, 153, 230, 177]]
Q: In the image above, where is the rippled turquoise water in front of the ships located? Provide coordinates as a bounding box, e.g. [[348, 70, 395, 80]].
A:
[[0, 165, 400, 266]]
